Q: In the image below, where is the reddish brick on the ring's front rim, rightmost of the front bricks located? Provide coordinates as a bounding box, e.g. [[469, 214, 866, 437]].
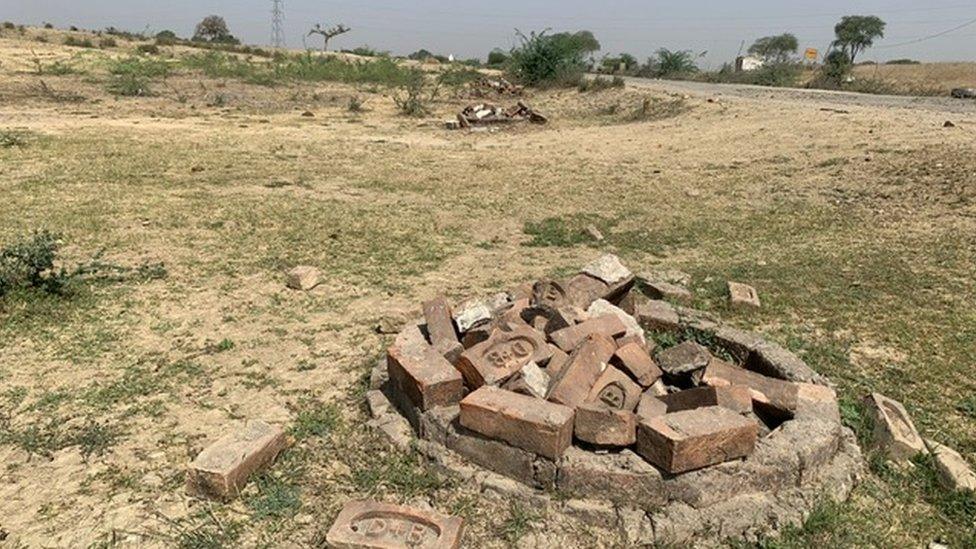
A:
[[637, 406, 758, 474]]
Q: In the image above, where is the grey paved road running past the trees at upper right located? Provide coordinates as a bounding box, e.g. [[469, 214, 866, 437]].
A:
[[626, 78, 976, 115]]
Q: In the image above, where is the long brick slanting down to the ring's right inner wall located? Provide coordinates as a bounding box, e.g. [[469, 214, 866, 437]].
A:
[[702, 358, 799, 419]]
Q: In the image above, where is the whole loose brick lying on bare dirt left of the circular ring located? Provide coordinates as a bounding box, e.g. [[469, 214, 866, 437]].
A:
[[186, 420, 289, 500]]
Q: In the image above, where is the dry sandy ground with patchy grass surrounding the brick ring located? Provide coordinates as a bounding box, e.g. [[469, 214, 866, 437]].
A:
[[0, 27, 976, 547]]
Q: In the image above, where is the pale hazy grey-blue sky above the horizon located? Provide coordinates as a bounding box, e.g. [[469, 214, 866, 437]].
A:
[[7, 0, 976, 68]]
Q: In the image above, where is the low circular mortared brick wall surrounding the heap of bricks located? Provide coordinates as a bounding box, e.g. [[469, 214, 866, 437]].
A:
[[367, 260, 861, 546]]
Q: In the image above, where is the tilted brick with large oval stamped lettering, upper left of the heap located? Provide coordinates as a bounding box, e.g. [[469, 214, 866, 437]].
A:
[[457, 326, 552, 389]]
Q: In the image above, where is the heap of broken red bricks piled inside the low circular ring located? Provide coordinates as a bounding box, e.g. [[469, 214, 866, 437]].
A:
[[378, 255, 809, 474]]
